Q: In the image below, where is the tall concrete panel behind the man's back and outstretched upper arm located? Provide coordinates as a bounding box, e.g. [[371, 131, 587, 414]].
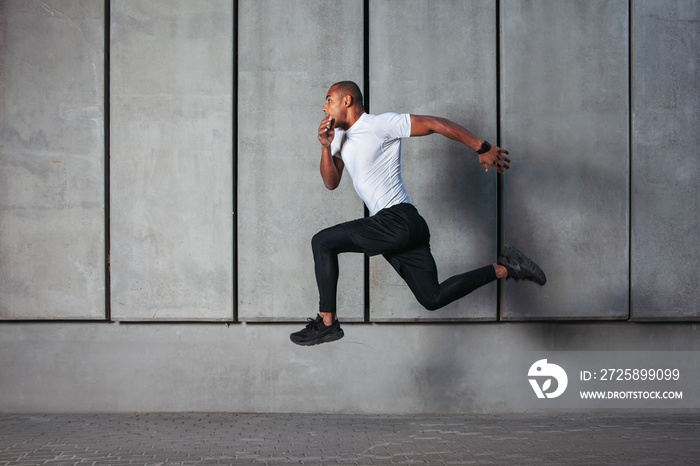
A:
[[370, 0, 497, 321]]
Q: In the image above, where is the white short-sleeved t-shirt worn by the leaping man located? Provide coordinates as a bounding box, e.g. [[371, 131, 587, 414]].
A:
[[331, 113, 411, 215]]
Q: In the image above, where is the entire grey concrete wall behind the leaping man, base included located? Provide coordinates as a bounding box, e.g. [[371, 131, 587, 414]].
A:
[[0, 0, 700, 413]]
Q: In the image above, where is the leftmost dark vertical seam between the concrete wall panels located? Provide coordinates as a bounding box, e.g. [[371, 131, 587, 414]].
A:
[[102, 0, 112, 322]]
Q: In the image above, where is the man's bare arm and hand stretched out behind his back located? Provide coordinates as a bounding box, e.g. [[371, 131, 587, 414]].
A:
[[411, 115, 510, 174]]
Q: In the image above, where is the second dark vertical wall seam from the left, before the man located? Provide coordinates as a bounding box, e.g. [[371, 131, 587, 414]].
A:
[[231, 0, 240, 322]]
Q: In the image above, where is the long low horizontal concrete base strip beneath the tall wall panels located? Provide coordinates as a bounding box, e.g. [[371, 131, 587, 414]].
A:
[[0, 322, 700, 415]]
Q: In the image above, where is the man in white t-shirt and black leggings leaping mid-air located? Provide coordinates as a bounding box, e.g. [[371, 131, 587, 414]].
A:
[[290, 81, 547, 346]]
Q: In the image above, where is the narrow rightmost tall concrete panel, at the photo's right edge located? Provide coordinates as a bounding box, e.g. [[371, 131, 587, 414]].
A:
[[632, 1, 700, 320]]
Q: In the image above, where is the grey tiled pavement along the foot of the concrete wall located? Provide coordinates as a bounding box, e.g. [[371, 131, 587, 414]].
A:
[[0, 414, 700, 465]]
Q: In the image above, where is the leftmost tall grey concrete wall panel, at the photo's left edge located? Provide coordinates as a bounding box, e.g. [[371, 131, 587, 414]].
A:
[[0, 0, 105, 319]]
